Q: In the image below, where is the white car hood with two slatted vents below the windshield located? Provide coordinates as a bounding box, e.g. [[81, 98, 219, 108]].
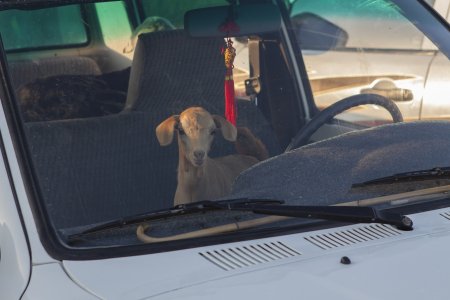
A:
[[63, 209, 450, 300]]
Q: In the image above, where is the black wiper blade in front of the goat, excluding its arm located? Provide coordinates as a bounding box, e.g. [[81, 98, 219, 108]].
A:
[[67, 198, 284, 240]]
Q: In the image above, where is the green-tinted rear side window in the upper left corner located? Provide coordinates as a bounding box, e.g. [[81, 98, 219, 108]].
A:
[[0, 5, 88, 50]]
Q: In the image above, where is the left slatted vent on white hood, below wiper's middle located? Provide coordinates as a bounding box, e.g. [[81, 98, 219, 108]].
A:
[[199, 242, 301, 271]]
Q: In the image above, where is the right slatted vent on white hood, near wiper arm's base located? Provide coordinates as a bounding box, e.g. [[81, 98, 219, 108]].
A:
[[305, 224, 402, 250]]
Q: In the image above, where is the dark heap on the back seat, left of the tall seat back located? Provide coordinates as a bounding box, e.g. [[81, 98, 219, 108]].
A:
[[16, 68, 130, 122]]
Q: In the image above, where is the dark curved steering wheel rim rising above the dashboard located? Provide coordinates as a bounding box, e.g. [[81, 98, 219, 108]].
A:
[[285, 94, 403, 152]]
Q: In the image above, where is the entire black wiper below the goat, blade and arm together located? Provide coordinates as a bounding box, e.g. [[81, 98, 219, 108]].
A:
[[68, 199, 413, 240]]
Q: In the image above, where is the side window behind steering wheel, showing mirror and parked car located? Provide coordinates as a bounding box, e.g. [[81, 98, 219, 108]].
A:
[[290, 0, 442, 125]]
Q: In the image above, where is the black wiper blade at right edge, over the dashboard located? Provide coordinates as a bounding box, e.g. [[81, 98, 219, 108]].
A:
[[352, 167, 450, 187]]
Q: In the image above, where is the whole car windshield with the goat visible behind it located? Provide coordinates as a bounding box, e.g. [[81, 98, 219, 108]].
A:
[[0, 0, 450, 258]]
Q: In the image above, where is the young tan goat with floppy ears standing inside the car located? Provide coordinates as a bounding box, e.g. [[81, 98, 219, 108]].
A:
[[156, 107, 268, 205]]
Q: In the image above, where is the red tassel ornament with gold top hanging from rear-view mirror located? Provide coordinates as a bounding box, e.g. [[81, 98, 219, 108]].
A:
[[222, 38, 237, 125]]
